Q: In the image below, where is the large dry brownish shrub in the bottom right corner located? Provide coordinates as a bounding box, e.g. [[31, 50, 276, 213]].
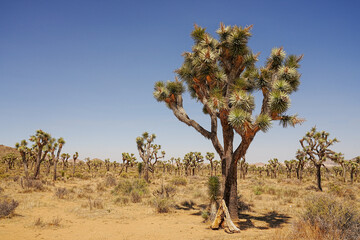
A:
[[301, 194, 360, 240]]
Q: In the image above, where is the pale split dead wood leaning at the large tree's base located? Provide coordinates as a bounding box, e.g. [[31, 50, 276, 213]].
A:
[[210, 199, 240, 233]]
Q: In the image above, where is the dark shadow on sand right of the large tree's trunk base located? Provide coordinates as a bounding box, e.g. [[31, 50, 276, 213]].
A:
[[238, 211, 291, 230]]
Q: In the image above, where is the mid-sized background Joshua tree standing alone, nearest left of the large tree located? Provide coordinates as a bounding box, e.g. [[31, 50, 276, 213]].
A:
[[136, 132, 165, 182]]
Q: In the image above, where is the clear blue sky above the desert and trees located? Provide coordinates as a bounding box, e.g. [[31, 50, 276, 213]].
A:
[[0, 0, 360, 163]]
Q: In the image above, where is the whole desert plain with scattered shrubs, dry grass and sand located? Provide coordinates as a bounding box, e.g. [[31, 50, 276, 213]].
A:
[[0, 140, 360, 239]]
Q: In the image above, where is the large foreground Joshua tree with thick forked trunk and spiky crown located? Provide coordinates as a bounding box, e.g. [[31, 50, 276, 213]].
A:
[[154, 24, 303, 218]]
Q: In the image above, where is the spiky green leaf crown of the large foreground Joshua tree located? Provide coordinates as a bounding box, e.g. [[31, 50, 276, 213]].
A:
[[154, 24, 303, 134]]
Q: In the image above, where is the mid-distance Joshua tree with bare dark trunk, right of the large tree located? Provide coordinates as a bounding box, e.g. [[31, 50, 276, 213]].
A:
[[300, 127, 339, 191]]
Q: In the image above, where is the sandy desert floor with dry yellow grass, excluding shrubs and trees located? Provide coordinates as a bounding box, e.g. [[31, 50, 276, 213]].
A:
[[0, 166, 360, 240]]
